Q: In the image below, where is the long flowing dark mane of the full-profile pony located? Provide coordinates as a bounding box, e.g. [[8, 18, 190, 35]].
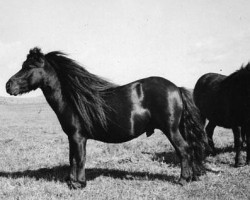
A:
[[45, 51, 116, 134]]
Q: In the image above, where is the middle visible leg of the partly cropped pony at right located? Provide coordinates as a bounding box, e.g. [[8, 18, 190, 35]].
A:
[[233, 127, 243, 167]]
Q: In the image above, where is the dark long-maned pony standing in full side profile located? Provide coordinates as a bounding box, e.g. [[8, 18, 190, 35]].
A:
[[6, 48, 208, 189]]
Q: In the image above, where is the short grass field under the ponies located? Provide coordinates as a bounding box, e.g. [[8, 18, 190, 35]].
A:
[[0, 98, 250, 200]]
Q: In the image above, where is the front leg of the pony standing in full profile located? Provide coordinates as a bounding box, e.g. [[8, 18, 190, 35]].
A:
[[67, 132, 87, 189]]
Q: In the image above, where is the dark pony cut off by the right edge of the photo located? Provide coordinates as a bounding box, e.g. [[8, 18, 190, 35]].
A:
[[193, 63, 250, 167]]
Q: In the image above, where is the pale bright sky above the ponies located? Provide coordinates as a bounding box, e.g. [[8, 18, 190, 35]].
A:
[[0, 0, 250, 96]]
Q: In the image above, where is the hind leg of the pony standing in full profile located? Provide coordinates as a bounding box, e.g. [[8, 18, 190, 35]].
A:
[[164, 129, 193, 185]]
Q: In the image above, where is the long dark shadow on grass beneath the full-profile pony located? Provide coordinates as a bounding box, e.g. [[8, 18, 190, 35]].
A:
[[0, 165, 177, 183]]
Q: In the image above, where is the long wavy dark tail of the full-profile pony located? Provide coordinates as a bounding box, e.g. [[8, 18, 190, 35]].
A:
[[179, 87, 211, 164]]
